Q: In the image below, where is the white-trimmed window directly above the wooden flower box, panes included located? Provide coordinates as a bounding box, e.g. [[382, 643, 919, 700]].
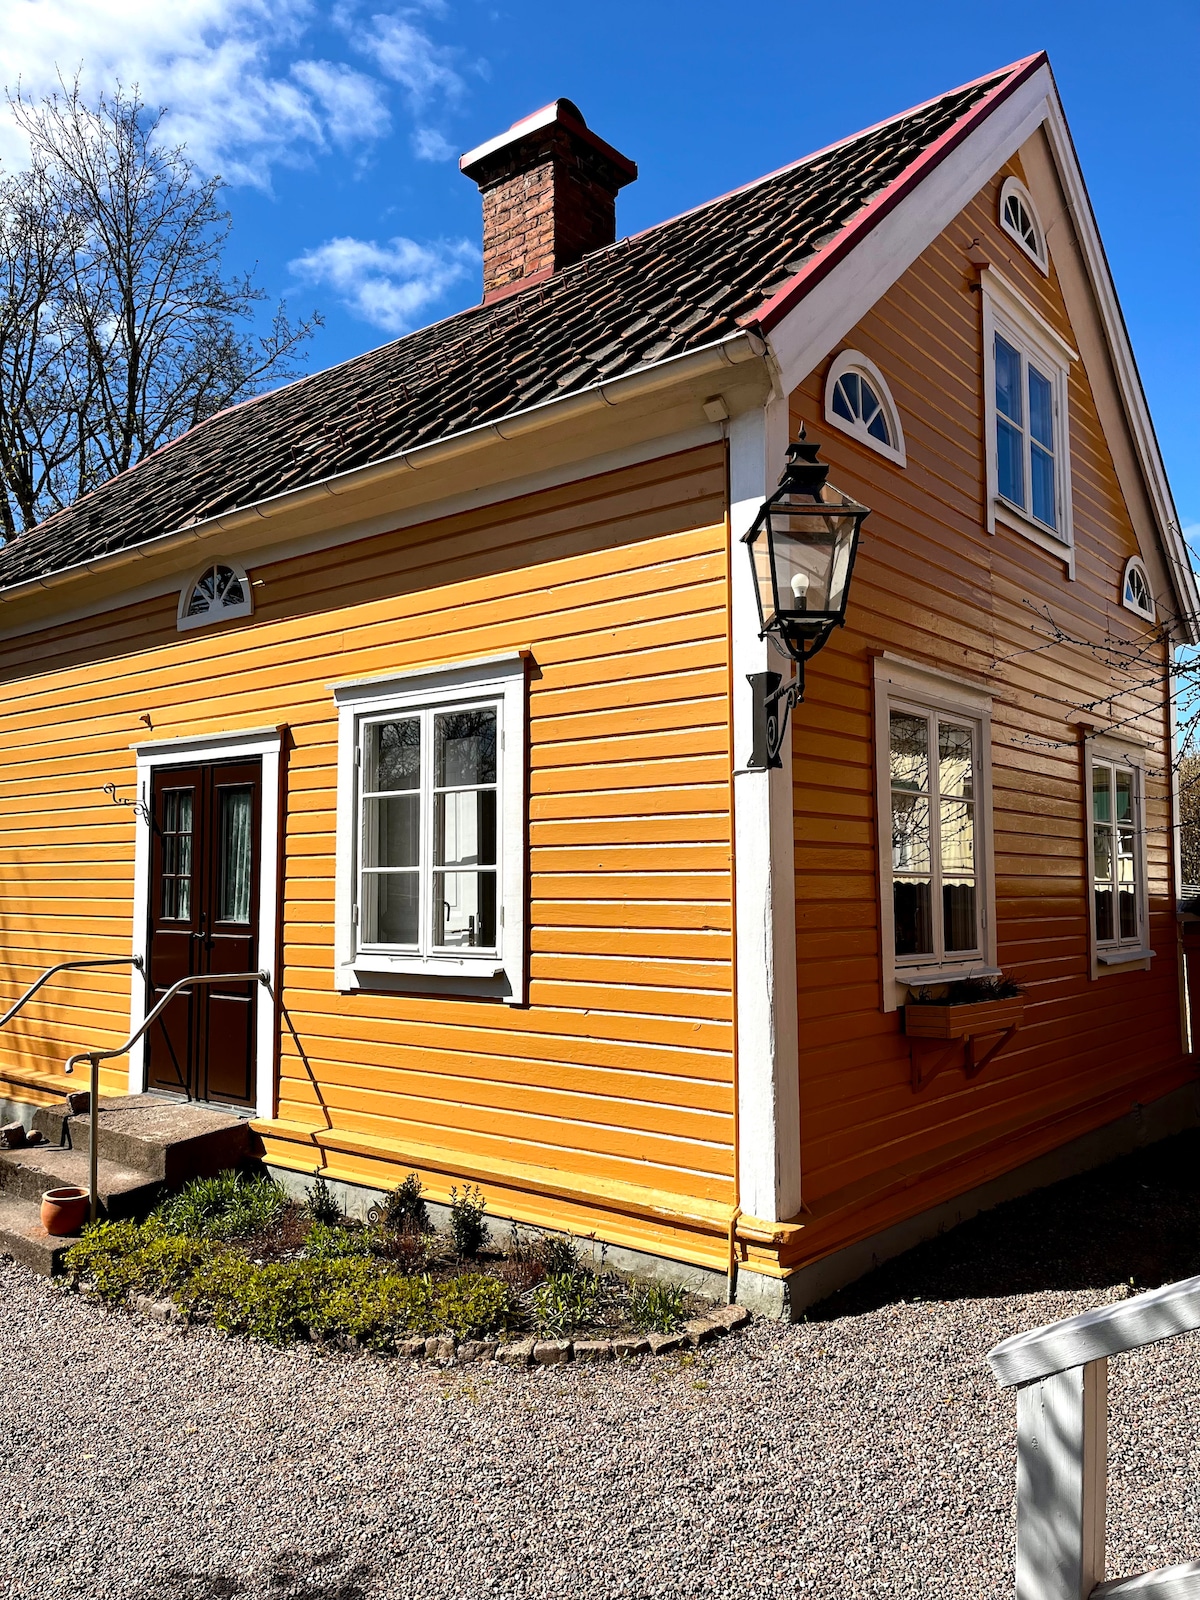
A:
[[875, 656, 995, 1008]]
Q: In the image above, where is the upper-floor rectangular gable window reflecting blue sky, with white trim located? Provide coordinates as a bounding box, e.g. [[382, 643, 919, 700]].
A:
[[982, 280, 1075, 573]]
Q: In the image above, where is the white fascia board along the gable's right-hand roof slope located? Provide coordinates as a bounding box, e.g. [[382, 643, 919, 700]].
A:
[[1045, 101, 1200, 645]]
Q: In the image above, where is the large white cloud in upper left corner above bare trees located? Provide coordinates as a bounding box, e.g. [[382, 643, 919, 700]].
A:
[[0, 0, 395, 187]]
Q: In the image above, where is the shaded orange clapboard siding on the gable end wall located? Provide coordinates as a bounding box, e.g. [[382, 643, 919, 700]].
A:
[[792, 137, 1190, 1259]]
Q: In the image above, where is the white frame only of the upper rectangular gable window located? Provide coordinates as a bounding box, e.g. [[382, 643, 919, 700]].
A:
[[981, 267, 1078, 579]]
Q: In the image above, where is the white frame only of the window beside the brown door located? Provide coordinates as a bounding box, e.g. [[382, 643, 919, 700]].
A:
[[330, 651, 528, 1005]]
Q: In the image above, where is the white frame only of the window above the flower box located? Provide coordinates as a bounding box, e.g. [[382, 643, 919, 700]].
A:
[[875, 651, 1000, 1011]]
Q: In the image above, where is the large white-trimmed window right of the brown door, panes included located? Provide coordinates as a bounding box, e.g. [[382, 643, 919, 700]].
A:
[[334, 656, 526, 1000]]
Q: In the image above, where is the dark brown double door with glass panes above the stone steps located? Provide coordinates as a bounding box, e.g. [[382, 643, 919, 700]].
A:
[[146, 762, 262, 1106]]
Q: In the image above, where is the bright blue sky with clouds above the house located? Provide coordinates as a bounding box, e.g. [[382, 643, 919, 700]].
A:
[[0, 0, 1200, 531]]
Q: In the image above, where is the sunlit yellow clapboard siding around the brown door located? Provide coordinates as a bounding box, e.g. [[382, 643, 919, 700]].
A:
[[0, 448, 733, 1253]]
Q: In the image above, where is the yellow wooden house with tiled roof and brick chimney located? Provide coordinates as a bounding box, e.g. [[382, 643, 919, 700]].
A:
[[0, 56, 1200, 1312]]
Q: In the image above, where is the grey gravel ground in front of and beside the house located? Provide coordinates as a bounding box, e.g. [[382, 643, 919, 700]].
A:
[[0, 1136, 1200, 1600]]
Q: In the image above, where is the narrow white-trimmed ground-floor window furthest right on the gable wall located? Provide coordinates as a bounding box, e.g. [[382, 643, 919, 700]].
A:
[[1088, 746, 1149, 965]]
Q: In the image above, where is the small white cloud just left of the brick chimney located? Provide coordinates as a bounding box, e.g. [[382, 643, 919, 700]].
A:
[[290, 238, 480, 334]]
